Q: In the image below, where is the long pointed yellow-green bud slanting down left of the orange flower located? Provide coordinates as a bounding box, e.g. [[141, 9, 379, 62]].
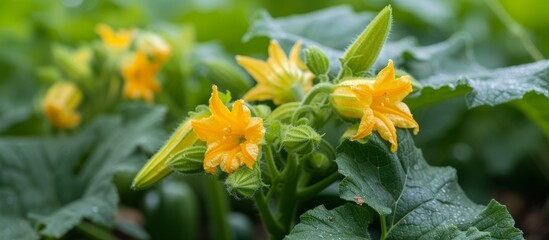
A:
[[132, 112, 209, 190]]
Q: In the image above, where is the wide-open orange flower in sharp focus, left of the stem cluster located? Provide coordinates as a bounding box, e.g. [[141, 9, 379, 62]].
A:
[[192, 85, 265, 174]]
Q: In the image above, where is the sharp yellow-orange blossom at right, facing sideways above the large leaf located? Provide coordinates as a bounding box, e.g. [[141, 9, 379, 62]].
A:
[[331, 60, 419, 152]]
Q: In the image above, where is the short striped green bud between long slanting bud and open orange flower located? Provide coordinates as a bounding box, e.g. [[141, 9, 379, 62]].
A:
[[167, 146, 206, 173]]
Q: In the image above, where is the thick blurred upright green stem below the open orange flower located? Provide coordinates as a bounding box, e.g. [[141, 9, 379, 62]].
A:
[[204, 177, 232, 240]]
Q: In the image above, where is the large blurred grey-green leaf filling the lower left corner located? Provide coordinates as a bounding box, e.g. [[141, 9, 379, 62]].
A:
[[0, 105, 166, 238]]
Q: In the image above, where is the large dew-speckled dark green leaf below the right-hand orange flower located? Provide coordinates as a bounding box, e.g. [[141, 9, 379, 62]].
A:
[[336, 130, 522, 239]]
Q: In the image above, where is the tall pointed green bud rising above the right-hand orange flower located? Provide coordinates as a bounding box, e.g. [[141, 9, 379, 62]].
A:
[[340, 6, 391, 76]]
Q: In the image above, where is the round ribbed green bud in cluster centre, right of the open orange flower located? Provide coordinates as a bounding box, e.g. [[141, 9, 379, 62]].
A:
[[282, 125, 322, 154]]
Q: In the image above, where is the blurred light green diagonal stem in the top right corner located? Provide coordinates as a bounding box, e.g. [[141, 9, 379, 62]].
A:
[[484, 0, 545, 61]]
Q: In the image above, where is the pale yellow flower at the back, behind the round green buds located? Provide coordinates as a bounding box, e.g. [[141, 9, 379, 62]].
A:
[[236, 40, 314, 105]]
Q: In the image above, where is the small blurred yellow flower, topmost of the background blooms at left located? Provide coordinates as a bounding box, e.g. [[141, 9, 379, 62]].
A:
[[95, 24, 135, 51]]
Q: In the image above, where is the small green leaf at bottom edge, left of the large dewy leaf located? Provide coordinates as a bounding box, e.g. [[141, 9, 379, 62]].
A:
[[285, 204, 372, 240]]
